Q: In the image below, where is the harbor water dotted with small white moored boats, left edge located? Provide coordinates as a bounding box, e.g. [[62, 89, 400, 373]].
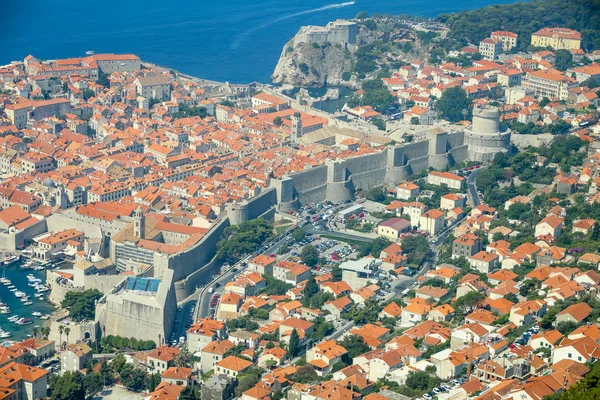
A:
[[0, 255, 57, 344]]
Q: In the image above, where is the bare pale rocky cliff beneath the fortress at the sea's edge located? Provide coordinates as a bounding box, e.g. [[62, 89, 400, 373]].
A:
[[272, 40, 353, 87]]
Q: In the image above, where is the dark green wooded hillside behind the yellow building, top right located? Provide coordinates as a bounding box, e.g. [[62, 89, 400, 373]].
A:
[[438, 0, 600, 51]]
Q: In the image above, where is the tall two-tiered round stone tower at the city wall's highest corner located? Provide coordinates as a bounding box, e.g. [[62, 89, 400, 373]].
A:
[[465, 106, 510, 163]]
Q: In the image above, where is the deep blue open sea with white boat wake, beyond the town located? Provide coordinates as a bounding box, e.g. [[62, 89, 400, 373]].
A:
[[0, 0, 513, 83]]
